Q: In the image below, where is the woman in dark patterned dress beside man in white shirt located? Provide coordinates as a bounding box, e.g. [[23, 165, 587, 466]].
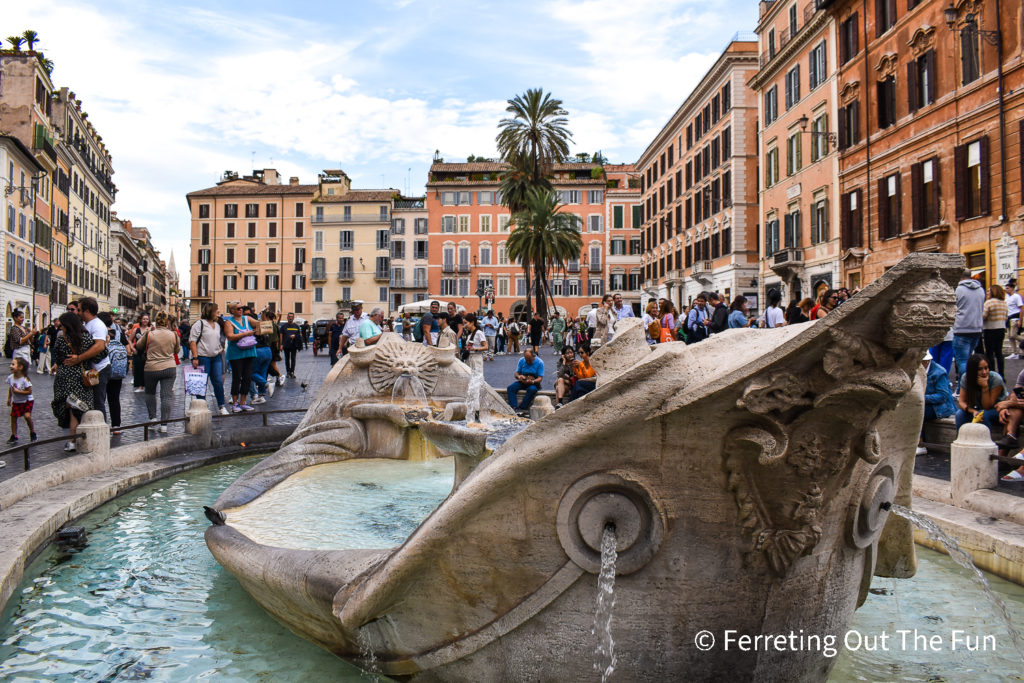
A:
[[50, 312, 98, 453]]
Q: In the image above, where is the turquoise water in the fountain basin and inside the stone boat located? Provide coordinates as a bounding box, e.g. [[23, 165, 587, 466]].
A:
[[0, 458, 1024, 683]]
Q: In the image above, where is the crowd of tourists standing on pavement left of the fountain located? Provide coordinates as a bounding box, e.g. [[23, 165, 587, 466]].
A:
[[4, 297, 309, 453]]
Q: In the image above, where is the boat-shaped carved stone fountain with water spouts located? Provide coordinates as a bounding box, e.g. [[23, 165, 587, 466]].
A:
[[206, 254, 963, 681]]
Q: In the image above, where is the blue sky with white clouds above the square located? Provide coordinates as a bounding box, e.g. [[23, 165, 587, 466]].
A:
[[0, 0, 758, 287]]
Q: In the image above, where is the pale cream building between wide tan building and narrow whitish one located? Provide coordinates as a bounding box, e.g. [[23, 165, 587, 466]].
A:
[[309, 169, 398, 319]]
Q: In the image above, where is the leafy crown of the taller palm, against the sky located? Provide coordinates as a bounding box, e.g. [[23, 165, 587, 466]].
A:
[[497, 88, 572, 189]]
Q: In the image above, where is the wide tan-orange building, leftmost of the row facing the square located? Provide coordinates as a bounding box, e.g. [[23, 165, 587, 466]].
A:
[[185, 169, 318, 319]]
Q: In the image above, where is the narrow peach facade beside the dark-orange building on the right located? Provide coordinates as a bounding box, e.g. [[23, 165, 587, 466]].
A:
[[750, 0, 840, 302]]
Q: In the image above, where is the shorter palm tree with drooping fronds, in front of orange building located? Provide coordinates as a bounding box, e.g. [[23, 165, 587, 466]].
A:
[[507, 187, 583, 317]]
